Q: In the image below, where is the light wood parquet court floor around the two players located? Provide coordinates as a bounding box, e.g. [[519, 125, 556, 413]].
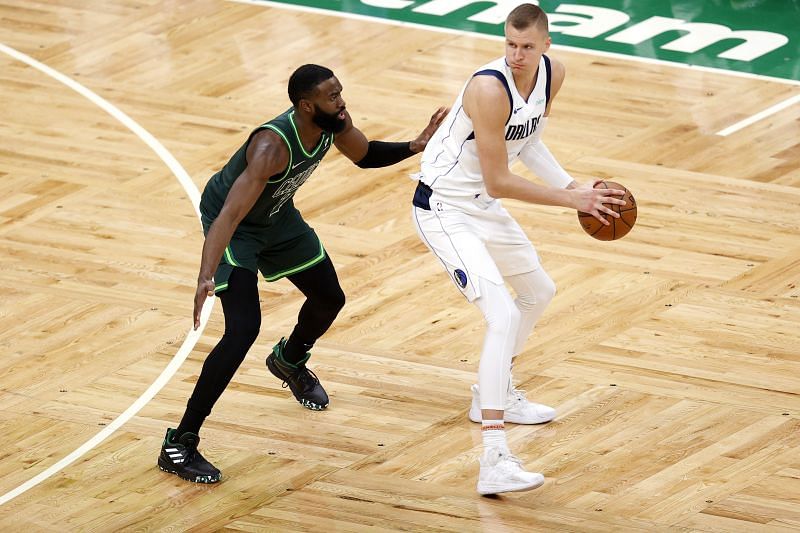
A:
[[0, 0, 800, 532]]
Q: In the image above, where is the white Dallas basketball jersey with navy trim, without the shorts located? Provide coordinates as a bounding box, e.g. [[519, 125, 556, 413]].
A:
[[419, 55, 550, 198]]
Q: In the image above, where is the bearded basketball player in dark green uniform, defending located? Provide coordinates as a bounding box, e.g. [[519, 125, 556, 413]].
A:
[[158, 65, 447, 483]]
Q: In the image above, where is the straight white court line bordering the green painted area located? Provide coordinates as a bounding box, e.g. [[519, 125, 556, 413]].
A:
[[227, 0, 800, 86]]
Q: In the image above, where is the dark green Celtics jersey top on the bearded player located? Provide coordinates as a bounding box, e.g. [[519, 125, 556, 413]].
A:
[[200, 107, 333, 237]]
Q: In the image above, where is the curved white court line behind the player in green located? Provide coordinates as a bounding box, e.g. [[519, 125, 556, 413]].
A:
[[0, 43, 214, 505]]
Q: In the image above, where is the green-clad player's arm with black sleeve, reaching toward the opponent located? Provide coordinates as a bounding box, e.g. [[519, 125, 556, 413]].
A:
[[334, 107, 448, 168]]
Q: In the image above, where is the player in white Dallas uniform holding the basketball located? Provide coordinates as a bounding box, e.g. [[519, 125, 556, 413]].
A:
[[413, 4, 624, 494]]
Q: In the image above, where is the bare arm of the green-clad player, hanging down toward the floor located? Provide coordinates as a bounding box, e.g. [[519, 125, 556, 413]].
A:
[[193, 130, 289, 329]]
